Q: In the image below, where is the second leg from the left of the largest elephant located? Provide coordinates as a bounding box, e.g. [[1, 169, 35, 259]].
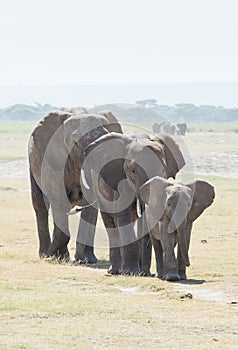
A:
[[48, 206, 70, 259]]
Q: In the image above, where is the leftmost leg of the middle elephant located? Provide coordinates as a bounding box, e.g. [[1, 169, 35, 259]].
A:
[[101, 211, 121, 275]]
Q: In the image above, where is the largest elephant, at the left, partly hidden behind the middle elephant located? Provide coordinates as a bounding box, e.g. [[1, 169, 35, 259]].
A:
[[29, 108, 122, 263]]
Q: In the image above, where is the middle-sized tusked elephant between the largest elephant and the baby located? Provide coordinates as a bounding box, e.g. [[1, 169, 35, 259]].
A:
[[83, 133, 184, 274]]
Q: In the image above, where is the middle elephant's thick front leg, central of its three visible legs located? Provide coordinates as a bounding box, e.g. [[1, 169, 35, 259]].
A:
[[116, 207, 140, 275]]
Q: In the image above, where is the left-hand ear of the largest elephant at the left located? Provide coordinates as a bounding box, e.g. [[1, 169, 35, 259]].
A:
[[32, 111, 72, 171]]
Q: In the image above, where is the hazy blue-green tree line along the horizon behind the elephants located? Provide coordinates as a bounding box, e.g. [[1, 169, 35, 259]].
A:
[[0, 99, 238, 123]]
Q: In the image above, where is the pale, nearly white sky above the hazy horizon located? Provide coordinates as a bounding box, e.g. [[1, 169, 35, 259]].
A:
[[0, 0, 238, 86]]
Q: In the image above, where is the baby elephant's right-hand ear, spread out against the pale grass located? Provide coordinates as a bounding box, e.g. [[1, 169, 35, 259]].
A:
[[187, 180, 215, 221]]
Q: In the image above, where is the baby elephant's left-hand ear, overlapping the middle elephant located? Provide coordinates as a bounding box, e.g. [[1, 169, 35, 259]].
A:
[[139, 176, 170, 220]]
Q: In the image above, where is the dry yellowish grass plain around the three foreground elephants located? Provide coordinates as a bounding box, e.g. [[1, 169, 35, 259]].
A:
[[0, 122, 238, 350]]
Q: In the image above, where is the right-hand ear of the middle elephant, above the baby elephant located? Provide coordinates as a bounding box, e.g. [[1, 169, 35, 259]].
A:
[[154, 134, 185, 179]]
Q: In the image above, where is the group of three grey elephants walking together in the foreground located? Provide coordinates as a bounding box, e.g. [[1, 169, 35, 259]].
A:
[[29, 108, 215, 281]]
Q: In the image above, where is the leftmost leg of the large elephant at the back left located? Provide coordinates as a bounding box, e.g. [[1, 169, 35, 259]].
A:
[[30, 173, 51, 257]]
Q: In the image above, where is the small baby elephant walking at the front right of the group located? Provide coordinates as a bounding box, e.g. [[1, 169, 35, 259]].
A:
[[140, 177, 215, 281]]
